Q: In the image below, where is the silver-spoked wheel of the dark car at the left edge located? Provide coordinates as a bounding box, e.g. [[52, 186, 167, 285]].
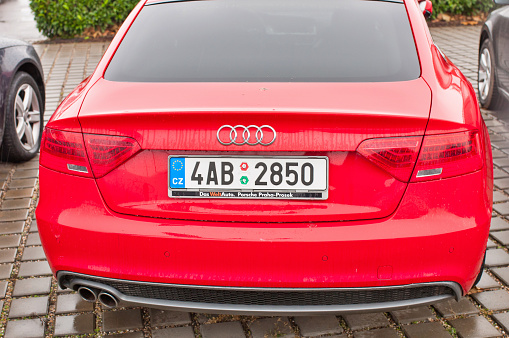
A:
[[0, 72, 43, 162]]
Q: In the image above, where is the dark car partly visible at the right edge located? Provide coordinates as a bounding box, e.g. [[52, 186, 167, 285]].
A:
[[478, 0, 509, 109]]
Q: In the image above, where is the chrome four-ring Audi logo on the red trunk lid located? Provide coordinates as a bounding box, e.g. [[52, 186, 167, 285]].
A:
[[217, 124, 276, 146]]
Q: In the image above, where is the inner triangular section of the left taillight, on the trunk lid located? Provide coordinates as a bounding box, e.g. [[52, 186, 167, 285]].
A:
[[85, 134, 141, 178]]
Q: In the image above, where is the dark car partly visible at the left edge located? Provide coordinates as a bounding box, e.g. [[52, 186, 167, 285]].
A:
[[0, 37, 45, 162]]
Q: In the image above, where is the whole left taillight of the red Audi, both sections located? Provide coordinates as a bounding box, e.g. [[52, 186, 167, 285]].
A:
[[40, 128, 141, 178]]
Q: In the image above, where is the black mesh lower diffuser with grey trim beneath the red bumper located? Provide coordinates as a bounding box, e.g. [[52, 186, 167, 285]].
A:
[[57, 271, 462, 316]]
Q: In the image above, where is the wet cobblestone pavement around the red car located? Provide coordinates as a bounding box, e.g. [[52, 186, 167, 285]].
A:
[[0, 27, 509, 338]]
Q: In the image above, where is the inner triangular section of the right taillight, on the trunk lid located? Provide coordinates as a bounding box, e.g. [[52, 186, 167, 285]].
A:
[[357, 136, 422, 182]]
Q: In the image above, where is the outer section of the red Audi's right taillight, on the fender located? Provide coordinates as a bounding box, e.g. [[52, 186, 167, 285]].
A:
[[412, 131, 483, 182]]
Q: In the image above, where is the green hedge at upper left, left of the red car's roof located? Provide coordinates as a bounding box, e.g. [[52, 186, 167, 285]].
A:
[[30, 0, 139, 38]]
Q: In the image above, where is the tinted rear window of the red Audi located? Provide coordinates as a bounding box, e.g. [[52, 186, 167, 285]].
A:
[[105, 0, 420, 82]]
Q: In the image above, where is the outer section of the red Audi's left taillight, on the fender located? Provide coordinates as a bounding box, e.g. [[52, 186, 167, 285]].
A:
[[39, 128, 92, 177]]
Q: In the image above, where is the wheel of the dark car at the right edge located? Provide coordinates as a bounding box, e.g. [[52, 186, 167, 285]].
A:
[[477, 39, 503, 109]]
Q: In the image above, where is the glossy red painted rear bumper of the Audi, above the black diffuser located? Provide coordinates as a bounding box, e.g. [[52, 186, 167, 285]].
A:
[[36, 167, 492, 304]]
